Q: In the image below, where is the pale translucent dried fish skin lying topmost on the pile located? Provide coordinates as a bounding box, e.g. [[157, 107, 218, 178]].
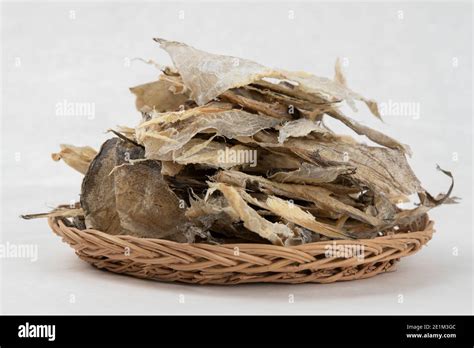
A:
[[154, 38, 380, 116]]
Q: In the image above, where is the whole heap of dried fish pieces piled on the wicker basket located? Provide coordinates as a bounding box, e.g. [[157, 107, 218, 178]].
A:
[[24, 39, 454, 246]]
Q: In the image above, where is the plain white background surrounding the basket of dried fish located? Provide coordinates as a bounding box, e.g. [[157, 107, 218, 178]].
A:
[[0, 1, 473, 314]]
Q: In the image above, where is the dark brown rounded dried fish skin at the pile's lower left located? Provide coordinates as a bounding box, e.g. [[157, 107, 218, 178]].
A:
[[81, 138, 200, 242]]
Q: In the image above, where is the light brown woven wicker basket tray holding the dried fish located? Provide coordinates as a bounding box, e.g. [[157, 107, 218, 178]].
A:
[[48, 215, 434, 285]]
